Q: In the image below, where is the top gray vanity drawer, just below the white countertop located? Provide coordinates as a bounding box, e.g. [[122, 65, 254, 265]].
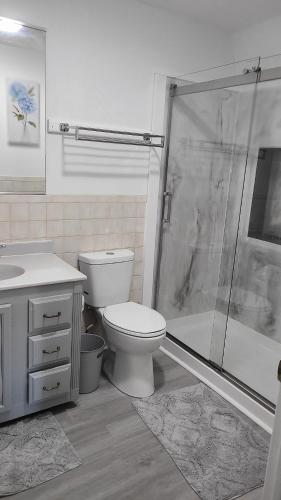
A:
[[29, 293, 72, 332]]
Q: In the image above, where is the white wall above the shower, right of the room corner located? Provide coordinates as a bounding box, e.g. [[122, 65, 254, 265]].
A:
[[232, 17, 281, 61]]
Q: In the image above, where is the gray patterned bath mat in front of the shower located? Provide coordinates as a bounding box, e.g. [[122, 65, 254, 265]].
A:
[[133, 383, 270, 500]]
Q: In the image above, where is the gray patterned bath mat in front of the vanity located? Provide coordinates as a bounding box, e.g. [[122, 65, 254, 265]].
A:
[[0, 412, 81, 496]]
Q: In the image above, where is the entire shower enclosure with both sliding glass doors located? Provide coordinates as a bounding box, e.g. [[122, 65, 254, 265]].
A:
[[155, 60, 281, 404]]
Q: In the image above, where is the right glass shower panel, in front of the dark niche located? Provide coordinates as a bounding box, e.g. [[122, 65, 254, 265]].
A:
[[223, 68, 281, 403]]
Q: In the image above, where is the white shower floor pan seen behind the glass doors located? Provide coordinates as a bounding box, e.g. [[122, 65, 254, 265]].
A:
[[167, 311, 281, 403]]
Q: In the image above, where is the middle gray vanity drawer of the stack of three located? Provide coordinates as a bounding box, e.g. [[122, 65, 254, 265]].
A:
[[28, 329, 71, 368]]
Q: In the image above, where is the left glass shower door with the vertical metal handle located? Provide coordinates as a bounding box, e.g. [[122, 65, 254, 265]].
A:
[[156, 73, 256, 366]]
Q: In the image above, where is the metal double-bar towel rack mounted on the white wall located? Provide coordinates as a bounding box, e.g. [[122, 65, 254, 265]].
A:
[[48, 120, 165, 148]]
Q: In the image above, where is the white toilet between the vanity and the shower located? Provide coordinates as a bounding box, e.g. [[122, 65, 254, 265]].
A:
[[79, 249, 166, 397]]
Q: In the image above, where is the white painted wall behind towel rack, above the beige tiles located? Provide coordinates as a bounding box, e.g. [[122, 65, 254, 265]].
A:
[[0, 0, 232, 194]]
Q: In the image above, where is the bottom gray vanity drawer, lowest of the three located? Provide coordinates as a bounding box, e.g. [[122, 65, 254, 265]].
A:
[[28, 364, 71, 404]]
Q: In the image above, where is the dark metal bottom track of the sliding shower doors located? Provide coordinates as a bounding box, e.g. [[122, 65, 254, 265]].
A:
[[166, 332, 276, 414]]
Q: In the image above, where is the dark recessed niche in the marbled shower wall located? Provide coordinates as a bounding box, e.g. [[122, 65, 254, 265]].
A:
[[248, 148, 281, 245]]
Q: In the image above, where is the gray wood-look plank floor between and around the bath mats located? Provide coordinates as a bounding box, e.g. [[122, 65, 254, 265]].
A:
[[9, 352, 262, 500]]
